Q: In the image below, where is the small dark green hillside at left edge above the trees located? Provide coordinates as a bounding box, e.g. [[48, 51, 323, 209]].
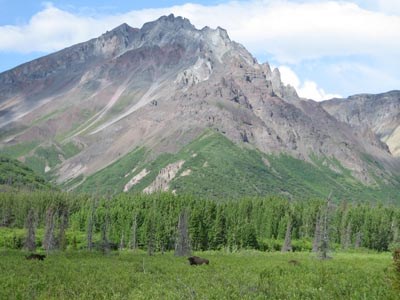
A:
[[0, 156, 50, 189]]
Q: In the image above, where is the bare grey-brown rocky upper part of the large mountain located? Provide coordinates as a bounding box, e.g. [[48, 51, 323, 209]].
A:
[[0, 15, 398, 183]]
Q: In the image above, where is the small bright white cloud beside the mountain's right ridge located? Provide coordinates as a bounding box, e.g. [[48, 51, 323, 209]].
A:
[[279, 66, 342, 101]]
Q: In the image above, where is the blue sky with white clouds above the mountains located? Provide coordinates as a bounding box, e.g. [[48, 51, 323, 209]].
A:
[[0, 0, 400, 101]]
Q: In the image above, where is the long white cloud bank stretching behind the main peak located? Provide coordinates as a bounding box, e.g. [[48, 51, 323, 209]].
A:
[[0, 0, 400, 63]]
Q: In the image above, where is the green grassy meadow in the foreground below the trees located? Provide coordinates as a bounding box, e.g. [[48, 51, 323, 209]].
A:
[[0, 251, 399, 300]]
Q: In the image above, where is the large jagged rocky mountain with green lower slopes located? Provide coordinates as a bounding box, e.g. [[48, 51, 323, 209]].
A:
[[0, 15, 400, 200]]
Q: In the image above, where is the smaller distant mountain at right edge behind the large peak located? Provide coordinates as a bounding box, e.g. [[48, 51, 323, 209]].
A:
[[322, 91, 400, 157]]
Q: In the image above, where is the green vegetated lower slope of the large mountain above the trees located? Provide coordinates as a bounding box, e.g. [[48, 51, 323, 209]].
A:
[[72, 130, 400, 202]]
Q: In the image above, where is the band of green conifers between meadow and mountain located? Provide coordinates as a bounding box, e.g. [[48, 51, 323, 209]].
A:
[[0, 191, 400, 256]]
